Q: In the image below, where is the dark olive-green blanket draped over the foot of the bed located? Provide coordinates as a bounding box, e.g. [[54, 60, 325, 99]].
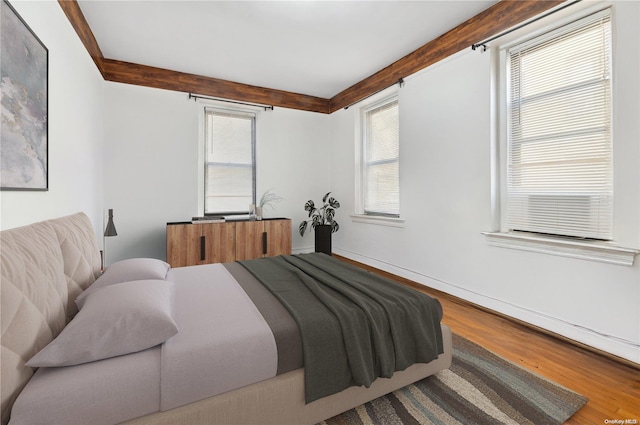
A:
[[240, 253, 443, 403]]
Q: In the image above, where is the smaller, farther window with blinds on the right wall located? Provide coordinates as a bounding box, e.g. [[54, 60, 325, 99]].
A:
[[361, 97, 400, 217]]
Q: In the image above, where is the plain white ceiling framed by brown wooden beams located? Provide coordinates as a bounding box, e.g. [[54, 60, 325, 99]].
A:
[[78, 0, 497, 98]]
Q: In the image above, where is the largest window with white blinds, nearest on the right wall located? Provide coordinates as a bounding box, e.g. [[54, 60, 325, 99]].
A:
[[506, 10, 613, 240]]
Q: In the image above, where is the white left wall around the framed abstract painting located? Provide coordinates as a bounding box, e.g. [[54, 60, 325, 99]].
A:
[[0, 1, 104, 235]]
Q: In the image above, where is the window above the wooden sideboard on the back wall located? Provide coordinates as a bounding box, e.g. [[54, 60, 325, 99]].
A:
[[204, 108, 256, 214]]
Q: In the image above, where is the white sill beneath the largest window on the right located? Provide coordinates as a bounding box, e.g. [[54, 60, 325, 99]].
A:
[[482, 232, 640, 266]]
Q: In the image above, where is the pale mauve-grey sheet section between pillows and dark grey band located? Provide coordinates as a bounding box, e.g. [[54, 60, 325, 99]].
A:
[[160, 264, 278, 410]]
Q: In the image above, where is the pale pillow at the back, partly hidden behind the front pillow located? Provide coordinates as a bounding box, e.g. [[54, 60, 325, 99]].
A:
[[76, 258, 171, 309]]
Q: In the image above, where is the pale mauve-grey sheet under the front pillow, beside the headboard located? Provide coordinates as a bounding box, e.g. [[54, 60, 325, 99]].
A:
[[9, 347, 160, 425]]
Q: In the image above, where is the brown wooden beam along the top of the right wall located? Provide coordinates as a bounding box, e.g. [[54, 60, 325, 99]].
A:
[[331, 0, 563, 112]]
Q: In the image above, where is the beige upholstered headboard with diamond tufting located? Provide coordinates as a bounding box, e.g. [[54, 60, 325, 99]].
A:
[[0, 213, 100, 424]]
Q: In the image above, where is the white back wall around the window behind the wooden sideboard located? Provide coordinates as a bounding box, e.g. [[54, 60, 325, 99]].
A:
[[104, 83, 330, 263]]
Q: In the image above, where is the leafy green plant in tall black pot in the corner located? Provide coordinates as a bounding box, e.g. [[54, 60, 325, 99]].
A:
[[298, 192, 340, 255]]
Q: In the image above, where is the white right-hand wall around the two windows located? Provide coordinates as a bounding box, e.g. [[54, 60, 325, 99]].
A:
[[331, 2, 640, 362]]
